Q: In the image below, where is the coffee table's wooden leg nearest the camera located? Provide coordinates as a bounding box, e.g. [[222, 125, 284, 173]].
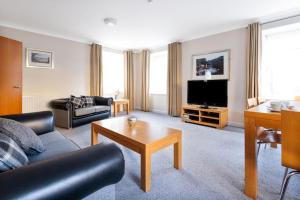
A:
[[141, 148, 151, 192]]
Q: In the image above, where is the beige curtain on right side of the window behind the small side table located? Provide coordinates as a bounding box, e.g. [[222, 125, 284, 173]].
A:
[[124, 51, 134, 110]]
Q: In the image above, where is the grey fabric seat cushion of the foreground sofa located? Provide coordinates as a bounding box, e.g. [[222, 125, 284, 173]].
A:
[[28, 131, 80, 163]]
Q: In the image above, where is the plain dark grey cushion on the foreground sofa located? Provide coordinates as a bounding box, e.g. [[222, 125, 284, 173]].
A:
[[0, 118, 46, 155]]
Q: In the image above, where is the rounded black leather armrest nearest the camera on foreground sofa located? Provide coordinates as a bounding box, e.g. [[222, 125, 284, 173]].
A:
[[0, 144, 125, 200]]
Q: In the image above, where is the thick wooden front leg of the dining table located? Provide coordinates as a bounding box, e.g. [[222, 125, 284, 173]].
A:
[[245, 117, 257, 199]]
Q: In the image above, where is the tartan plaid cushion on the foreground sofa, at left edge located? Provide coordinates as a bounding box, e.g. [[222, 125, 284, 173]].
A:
[[0, 132, 28, 172]]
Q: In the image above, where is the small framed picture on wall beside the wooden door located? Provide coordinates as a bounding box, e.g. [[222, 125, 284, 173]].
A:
[[26, 48, 54, 69]]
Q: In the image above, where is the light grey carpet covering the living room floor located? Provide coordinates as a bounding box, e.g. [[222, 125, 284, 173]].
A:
[[59, 112, 300, 200]]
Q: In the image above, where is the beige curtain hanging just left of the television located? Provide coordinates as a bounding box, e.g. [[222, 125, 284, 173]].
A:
[[168, 42, 182, 116]]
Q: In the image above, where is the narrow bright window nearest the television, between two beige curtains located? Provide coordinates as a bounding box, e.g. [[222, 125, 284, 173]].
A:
[[149, 51, 168, 94]]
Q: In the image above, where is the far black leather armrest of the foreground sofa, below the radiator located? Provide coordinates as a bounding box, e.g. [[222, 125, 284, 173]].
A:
[[1, 111, 54, 135]]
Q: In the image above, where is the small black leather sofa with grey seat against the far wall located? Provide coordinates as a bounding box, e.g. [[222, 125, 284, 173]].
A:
[[50, 96, 113, 128]]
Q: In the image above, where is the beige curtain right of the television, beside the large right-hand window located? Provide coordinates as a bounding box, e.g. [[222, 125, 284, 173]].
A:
[[246, 23, 261, 106]]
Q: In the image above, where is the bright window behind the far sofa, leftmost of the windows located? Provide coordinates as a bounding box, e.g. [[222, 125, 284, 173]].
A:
[[102, 50, 124, 97]]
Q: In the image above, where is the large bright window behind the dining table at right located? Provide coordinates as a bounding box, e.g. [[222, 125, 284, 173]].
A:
[[259, 24, 300, 99]]
